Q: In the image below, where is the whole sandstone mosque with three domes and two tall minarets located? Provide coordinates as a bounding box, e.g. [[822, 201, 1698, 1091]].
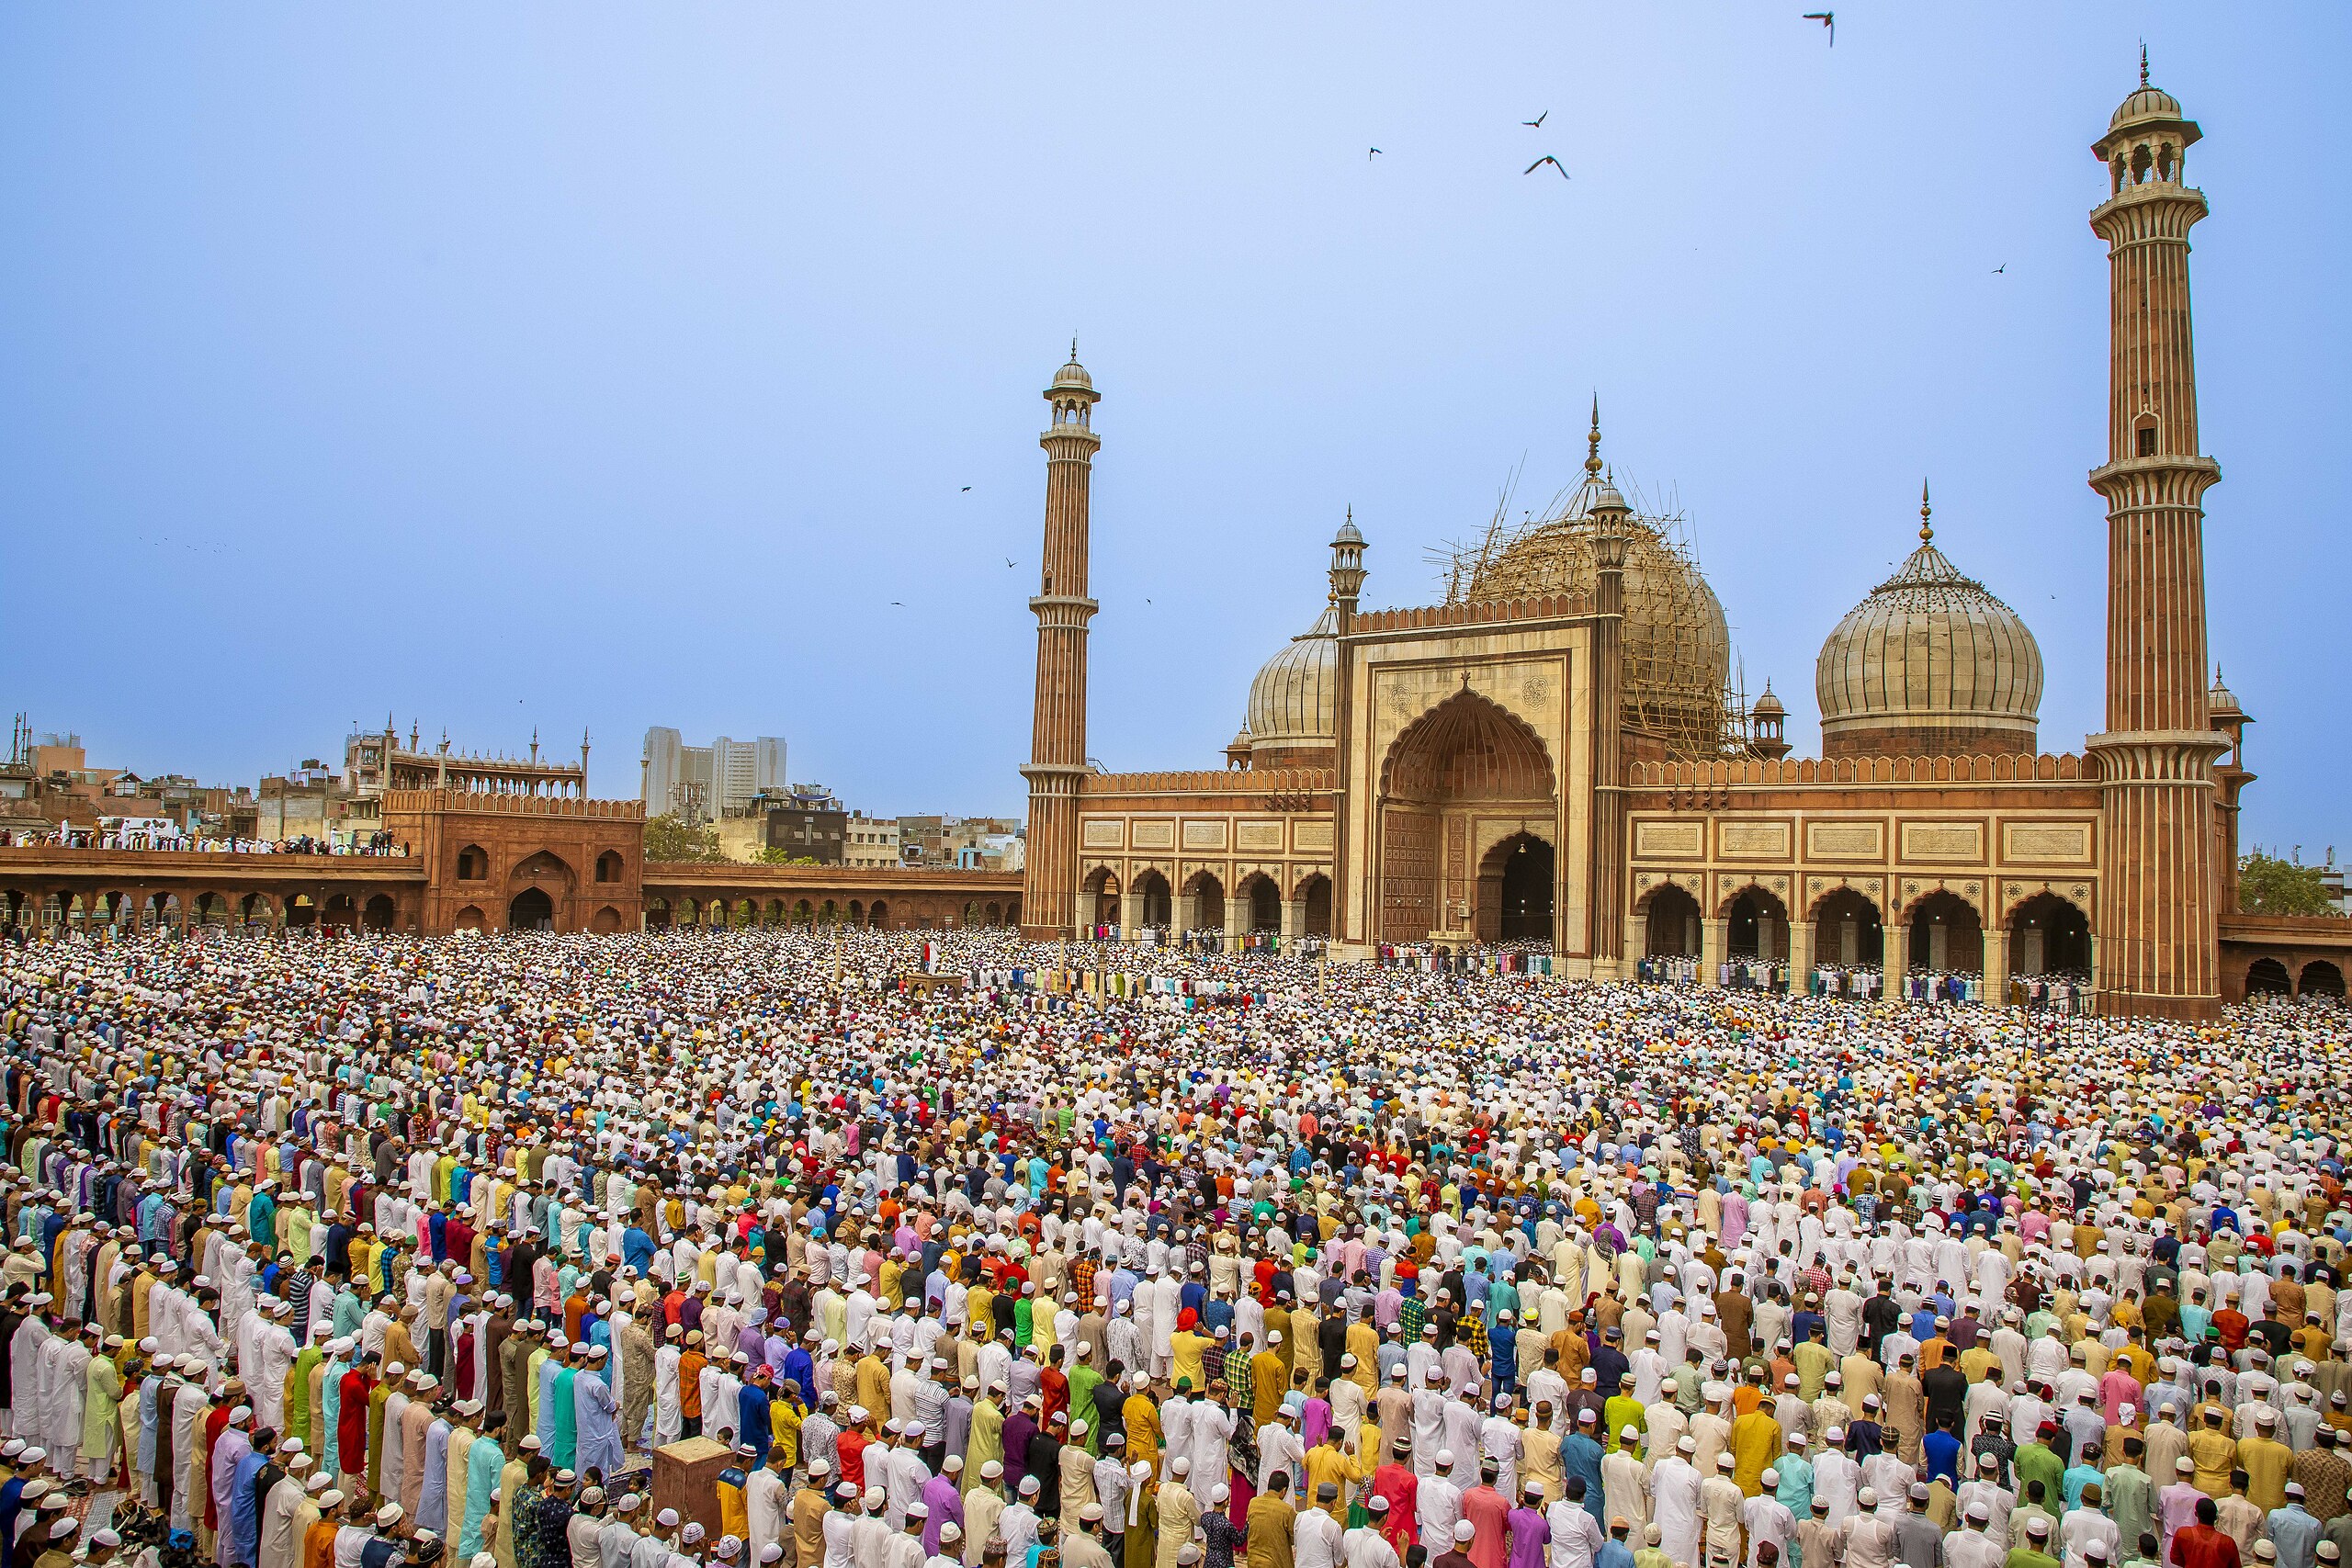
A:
[[1023, 63, 2295, 1018]]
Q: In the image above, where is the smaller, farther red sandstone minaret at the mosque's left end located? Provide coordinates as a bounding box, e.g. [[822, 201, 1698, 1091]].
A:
[[1021, 339, 1103, 938]]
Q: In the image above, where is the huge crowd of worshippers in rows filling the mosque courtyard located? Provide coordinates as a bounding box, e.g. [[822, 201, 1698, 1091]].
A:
[[0, 931, 2352, 1568]]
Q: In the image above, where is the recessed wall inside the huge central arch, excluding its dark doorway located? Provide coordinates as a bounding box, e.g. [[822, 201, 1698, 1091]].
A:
[[1374, 684, 1559, 942]]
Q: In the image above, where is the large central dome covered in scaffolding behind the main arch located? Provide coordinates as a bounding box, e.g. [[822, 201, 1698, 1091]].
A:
[[1430, 461, 1750, 761]]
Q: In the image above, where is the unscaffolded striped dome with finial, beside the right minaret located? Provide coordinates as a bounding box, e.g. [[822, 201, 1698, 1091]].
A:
[[1814, 491, 2041, 757]]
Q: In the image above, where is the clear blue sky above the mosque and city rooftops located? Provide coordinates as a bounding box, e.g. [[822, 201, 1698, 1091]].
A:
[[0, 0, 2352, 856]]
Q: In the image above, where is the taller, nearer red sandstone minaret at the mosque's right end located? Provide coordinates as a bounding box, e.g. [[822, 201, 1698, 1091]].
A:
[[2088, 50, 2227, 1018]]
